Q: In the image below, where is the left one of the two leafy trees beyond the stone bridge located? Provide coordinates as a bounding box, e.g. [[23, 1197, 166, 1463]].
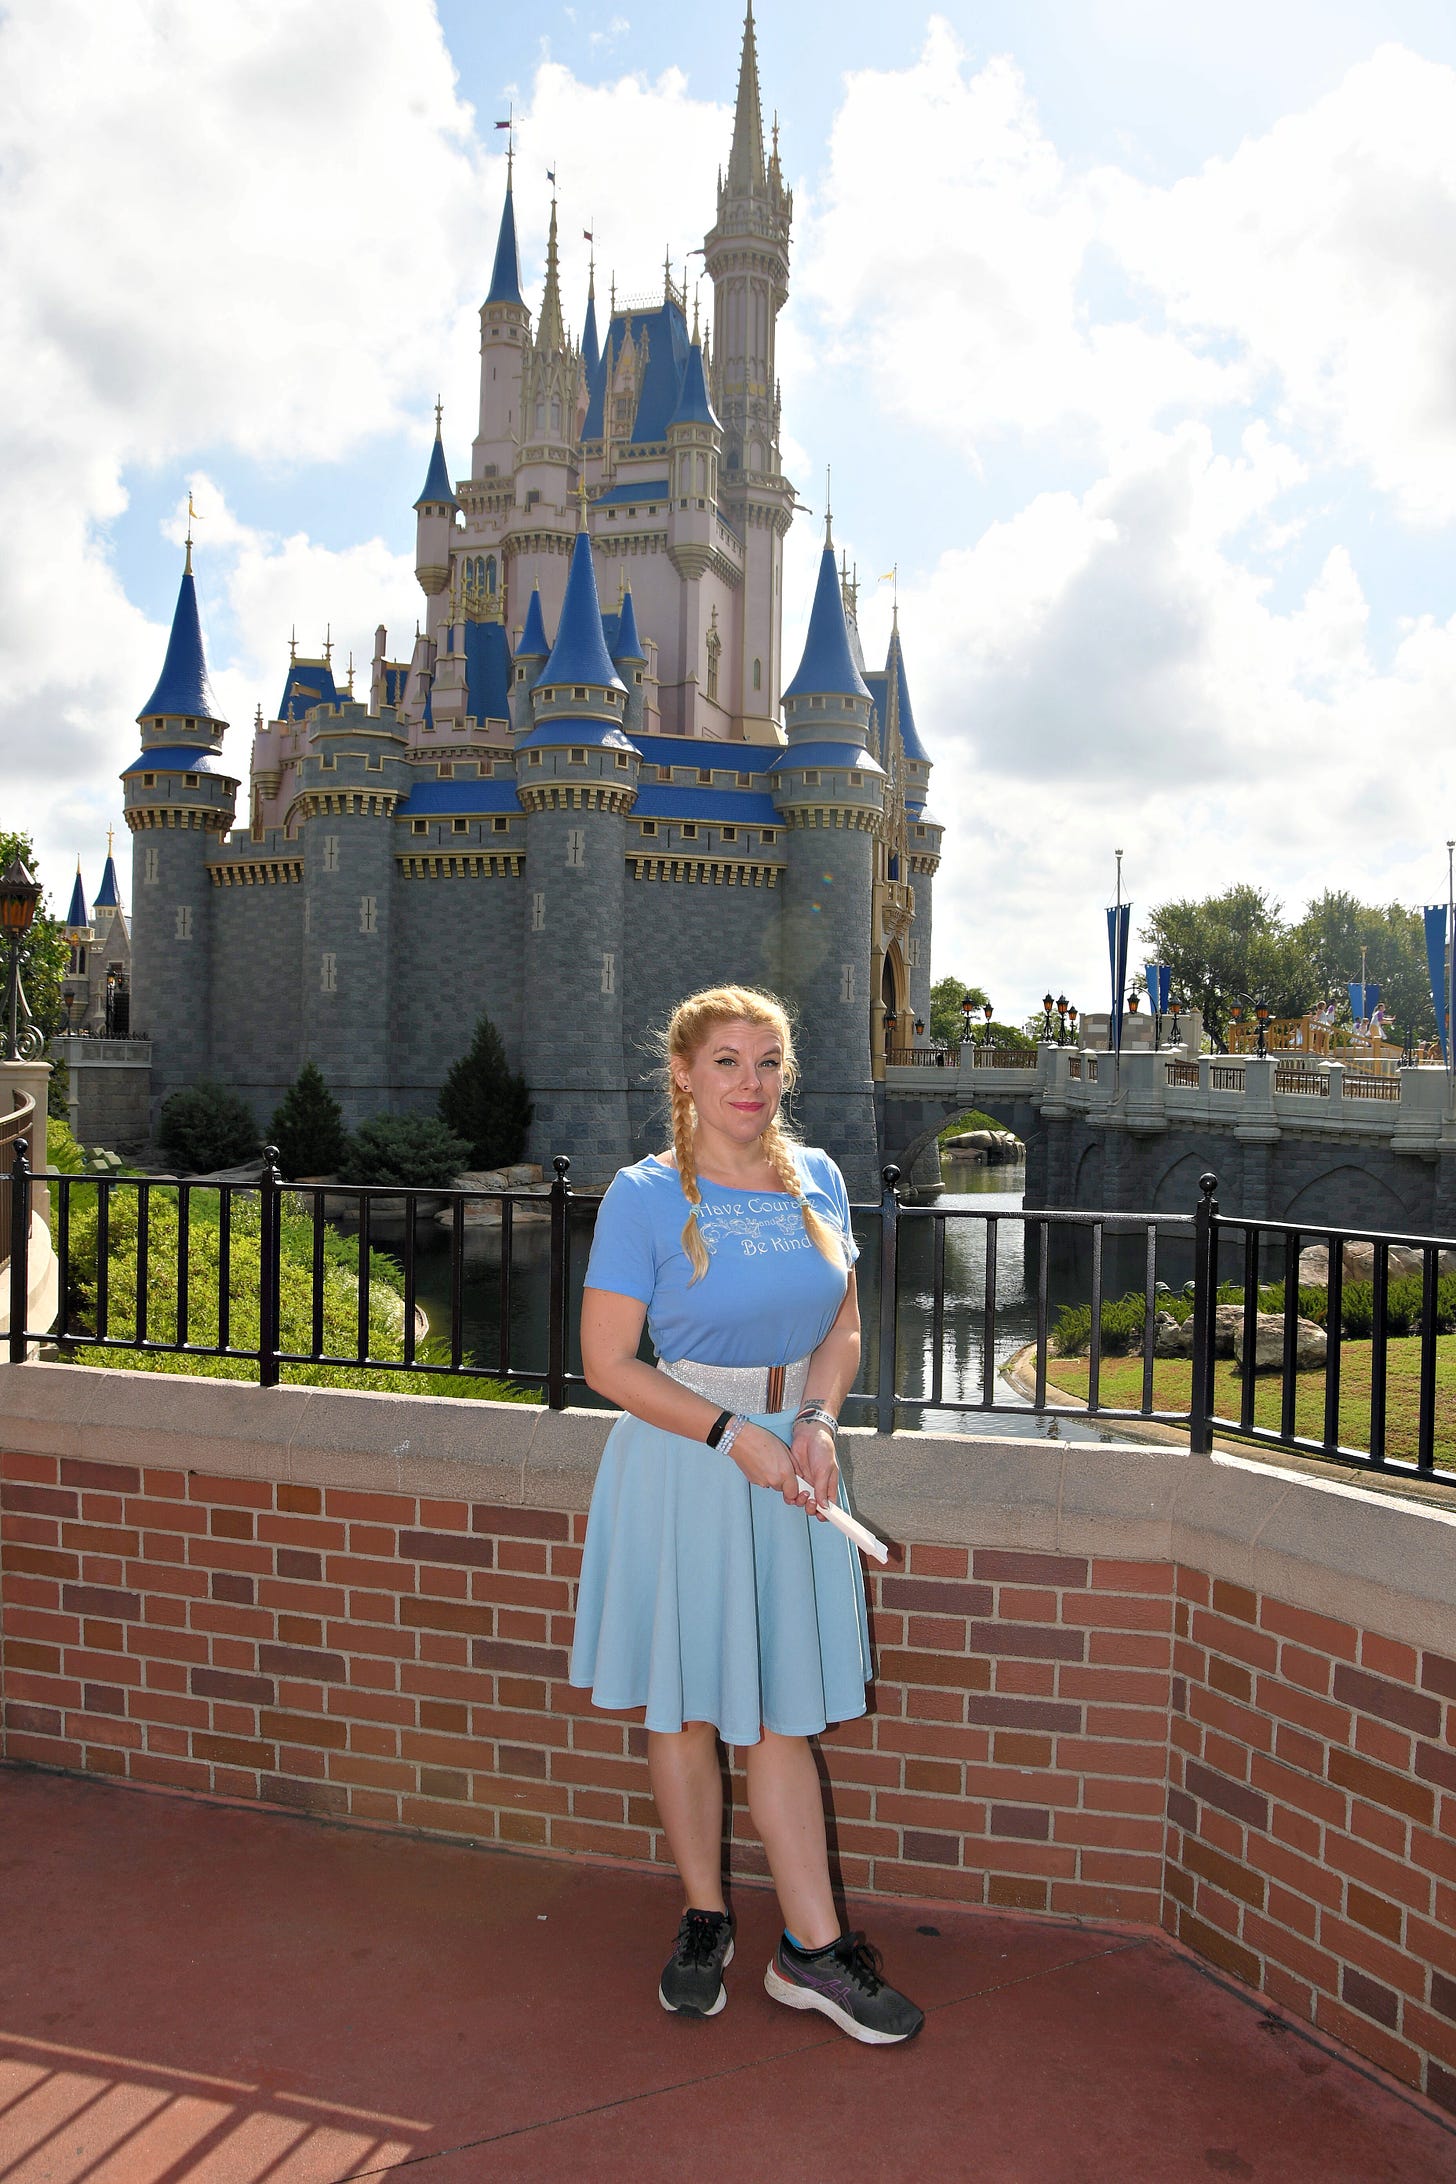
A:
[[1137, 885, 1323, 1048]]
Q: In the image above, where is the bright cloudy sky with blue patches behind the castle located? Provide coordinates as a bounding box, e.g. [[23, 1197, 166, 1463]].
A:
[[0, 0, 1456, 1018]]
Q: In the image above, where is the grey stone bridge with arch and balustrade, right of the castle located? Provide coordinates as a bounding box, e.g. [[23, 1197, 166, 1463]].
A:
[[882, 1044, 1456, 1236]]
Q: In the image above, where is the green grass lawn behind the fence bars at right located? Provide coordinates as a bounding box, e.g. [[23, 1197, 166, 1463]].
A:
[[1048, 1334, 1456, 1468]]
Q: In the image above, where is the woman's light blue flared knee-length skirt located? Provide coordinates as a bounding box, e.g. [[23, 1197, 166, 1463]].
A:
[[570, 1409, 873, 1745]]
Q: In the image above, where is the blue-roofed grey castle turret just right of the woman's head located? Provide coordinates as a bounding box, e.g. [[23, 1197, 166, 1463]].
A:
[[768, 522, 884, 1192]]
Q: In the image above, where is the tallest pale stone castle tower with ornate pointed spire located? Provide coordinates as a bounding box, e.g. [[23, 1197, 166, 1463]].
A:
[[703, 4, 795, 743]]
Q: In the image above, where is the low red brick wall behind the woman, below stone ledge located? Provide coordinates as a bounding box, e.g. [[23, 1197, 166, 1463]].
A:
[[0, 1455, 1456, 2110]]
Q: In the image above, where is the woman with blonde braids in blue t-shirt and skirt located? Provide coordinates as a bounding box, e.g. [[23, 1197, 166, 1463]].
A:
[[572, 987, 923, 2042]]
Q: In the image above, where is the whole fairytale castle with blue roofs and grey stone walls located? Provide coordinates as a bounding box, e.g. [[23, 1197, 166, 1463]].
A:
[[108, 9, 941, 1190]]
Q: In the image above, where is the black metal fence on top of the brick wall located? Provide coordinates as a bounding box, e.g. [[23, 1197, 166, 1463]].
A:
[[9, 1140, 1456, 1474]]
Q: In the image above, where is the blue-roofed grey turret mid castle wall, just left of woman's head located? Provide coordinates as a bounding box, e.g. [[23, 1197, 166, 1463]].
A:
[[515, 511, 640, 1184]]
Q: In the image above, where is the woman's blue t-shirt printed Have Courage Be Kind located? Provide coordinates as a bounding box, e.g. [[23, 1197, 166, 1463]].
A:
[[587, 1144, 860, 1365]]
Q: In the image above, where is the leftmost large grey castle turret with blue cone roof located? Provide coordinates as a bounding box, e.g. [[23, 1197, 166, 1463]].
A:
[[122, 539, 238, 1116]]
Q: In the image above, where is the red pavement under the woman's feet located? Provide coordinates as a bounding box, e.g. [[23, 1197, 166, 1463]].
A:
[[0, 1769, 1456, 2184]]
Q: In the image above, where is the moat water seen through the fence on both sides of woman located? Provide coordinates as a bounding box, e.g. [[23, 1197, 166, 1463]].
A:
[[401, 1160, 1181, 1441]]
